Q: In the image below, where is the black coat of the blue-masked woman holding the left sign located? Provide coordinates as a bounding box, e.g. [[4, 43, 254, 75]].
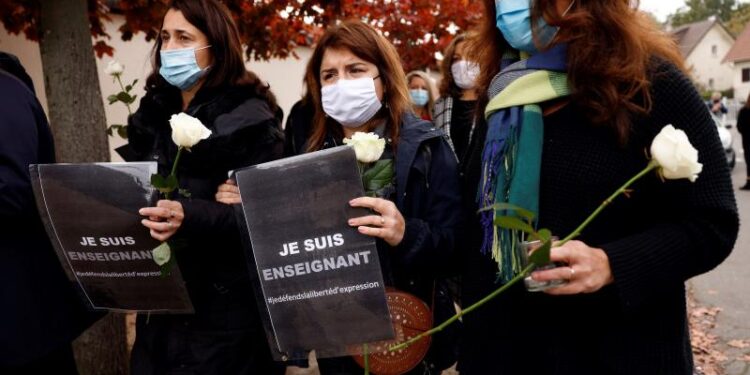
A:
[[128, 83, 283, 375]]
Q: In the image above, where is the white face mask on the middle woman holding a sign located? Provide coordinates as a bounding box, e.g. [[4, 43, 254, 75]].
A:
[[320, 77, 382, 128]]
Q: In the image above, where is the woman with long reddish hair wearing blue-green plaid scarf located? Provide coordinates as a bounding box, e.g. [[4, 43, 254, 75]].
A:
[[459, 0, 738, 375]]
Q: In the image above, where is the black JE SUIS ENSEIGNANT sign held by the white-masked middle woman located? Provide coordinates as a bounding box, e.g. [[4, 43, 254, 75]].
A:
[[236, 147, 393, 359]]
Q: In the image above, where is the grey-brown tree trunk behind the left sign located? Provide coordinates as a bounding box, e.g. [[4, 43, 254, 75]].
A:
[[39, 0, 128, 375]]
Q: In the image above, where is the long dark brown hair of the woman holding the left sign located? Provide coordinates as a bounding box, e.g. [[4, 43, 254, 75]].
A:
[[146, 0, 276, 108]]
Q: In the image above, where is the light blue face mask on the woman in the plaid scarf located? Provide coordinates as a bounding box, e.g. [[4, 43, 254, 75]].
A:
[[495, 0, 575, 54]]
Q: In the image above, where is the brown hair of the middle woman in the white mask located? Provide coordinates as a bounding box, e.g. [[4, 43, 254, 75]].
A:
[[305, 20, 412, 151]]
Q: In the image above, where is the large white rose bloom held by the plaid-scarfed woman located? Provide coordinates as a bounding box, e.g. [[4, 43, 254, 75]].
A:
[[651, 125, 703, 182]]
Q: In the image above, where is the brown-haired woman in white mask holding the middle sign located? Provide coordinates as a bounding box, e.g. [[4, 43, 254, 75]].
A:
[[306, 21, 461, 375]]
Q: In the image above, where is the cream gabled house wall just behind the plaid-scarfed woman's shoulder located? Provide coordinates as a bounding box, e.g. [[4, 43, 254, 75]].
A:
[[686, 24, 734, 90]]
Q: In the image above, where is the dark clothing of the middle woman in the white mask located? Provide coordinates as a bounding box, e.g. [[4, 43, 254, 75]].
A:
[[318, 113, 462, 375]]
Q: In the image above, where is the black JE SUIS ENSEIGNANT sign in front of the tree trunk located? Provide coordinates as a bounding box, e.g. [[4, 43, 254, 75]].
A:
[[30, 163, 192, 313]]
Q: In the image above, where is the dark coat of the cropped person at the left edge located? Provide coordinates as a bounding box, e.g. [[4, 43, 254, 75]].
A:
[[0, 70, 94, 367]]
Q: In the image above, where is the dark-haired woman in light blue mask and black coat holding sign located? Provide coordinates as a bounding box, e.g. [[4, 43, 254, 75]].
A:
[[128, 0, 283, 375]]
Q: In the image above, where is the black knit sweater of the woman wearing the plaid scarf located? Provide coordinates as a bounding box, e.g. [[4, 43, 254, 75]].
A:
[[459, 63, 739, 375]]
